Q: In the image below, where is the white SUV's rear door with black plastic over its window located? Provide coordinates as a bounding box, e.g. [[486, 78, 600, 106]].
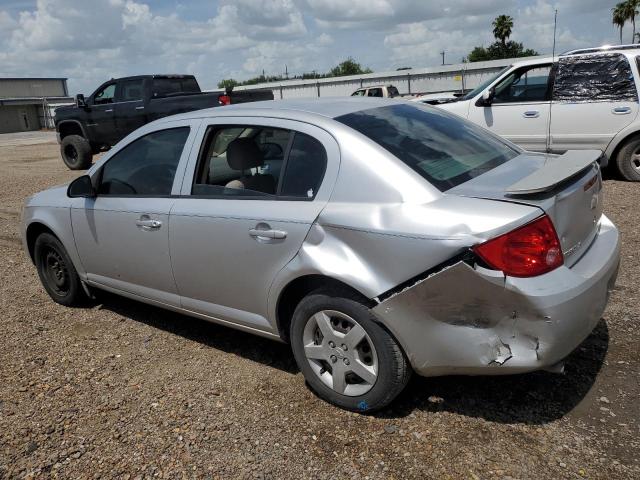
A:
[[550, 53, 638, 152]]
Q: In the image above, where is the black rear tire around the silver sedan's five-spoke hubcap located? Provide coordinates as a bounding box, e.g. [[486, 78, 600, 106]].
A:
[[290, 292, 412, 413]]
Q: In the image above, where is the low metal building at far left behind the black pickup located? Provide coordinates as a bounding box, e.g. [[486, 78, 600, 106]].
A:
[[0, 78, 73, 133]]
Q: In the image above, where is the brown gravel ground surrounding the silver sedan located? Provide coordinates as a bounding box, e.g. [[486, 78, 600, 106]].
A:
[[0, 134, 640, 480]]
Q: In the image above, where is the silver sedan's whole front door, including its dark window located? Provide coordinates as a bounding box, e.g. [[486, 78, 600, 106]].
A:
[[71, 126, 190, 305]]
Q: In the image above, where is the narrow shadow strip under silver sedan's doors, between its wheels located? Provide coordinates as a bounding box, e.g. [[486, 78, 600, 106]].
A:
[[98, 292, 299, 374]]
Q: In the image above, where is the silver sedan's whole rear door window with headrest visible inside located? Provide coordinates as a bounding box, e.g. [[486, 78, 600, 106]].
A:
[[192, 125, 326, 199]]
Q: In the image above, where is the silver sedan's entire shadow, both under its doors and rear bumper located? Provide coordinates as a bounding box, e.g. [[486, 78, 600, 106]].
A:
[[94, 292, 609, 425]]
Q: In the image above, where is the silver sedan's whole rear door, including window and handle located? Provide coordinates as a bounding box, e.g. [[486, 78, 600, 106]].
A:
[[169, 118, 339, 331]]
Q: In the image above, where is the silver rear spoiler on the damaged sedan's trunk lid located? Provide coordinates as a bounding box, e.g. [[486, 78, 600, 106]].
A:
[[505, 150, 602, 195]]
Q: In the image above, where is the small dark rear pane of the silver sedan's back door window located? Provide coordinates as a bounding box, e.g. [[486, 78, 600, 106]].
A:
[[280, 133, 327, 198]]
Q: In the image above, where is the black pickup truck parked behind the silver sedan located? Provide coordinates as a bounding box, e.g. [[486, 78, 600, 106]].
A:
[[55, 75, 273, 170]]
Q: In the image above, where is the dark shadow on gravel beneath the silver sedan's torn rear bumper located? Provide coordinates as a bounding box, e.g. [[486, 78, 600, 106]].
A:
[[377, 319, 609, 425]]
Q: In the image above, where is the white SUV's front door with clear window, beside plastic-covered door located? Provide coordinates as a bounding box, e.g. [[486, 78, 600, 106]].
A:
[[469, 64, 551, 151]]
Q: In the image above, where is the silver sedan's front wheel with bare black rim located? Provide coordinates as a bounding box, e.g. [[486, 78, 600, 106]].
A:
[[34, 233, 87, 307]]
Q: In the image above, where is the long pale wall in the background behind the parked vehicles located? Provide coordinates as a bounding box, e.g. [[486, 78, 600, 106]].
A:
[[216, 57, 533, 99]]
